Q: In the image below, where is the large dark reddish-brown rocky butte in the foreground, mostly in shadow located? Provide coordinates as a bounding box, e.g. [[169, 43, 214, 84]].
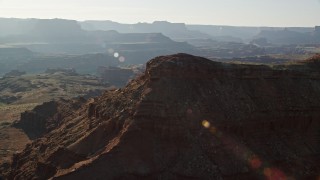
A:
[[8, 54, 320, 179]]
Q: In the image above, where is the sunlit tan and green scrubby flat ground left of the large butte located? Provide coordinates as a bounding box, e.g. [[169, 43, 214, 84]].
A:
[[0, 73, 109, 172]]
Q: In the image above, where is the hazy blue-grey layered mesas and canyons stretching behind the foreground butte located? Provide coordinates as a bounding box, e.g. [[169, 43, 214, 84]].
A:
[[0, 18, 320, 76]]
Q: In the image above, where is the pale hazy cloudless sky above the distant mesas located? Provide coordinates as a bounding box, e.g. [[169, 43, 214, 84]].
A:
[[0, 0, 320, 26]]
